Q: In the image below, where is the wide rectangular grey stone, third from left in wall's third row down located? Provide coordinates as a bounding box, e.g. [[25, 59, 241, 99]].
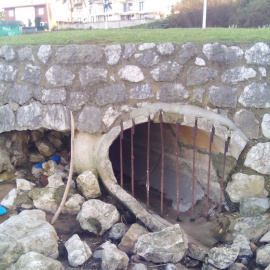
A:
[[34, 87, 67, 104]]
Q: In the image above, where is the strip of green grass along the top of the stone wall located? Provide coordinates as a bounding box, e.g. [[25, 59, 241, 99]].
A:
[[0, 28, 270, 46]]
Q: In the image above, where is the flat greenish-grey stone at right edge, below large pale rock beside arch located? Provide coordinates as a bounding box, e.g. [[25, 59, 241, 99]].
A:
[[240, 198, 270, 217]]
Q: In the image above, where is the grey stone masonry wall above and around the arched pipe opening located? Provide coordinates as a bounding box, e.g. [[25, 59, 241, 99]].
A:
[[0, 42, 270, 190]]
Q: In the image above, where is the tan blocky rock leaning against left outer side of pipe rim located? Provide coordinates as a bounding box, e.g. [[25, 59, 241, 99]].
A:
[[76, 170, 101, 199]]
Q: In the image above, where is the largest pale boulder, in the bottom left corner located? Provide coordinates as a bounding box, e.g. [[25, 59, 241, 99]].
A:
[[0, 210, 58, 270]]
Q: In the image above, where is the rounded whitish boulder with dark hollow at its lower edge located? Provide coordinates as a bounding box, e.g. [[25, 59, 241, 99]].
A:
[[77, 199, 120, 235]]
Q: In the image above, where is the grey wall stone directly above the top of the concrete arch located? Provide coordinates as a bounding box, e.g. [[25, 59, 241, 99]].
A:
[[159, 83, 189, 101]]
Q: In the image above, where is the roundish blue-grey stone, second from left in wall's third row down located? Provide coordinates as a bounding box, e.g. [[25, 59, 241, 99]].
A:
[[9, 83, 32, 105]]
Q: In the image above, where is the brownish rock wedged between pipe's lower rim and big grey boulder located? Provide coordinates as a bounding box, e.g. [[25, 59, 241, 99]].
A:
[[118, 223, 149, 254]]
